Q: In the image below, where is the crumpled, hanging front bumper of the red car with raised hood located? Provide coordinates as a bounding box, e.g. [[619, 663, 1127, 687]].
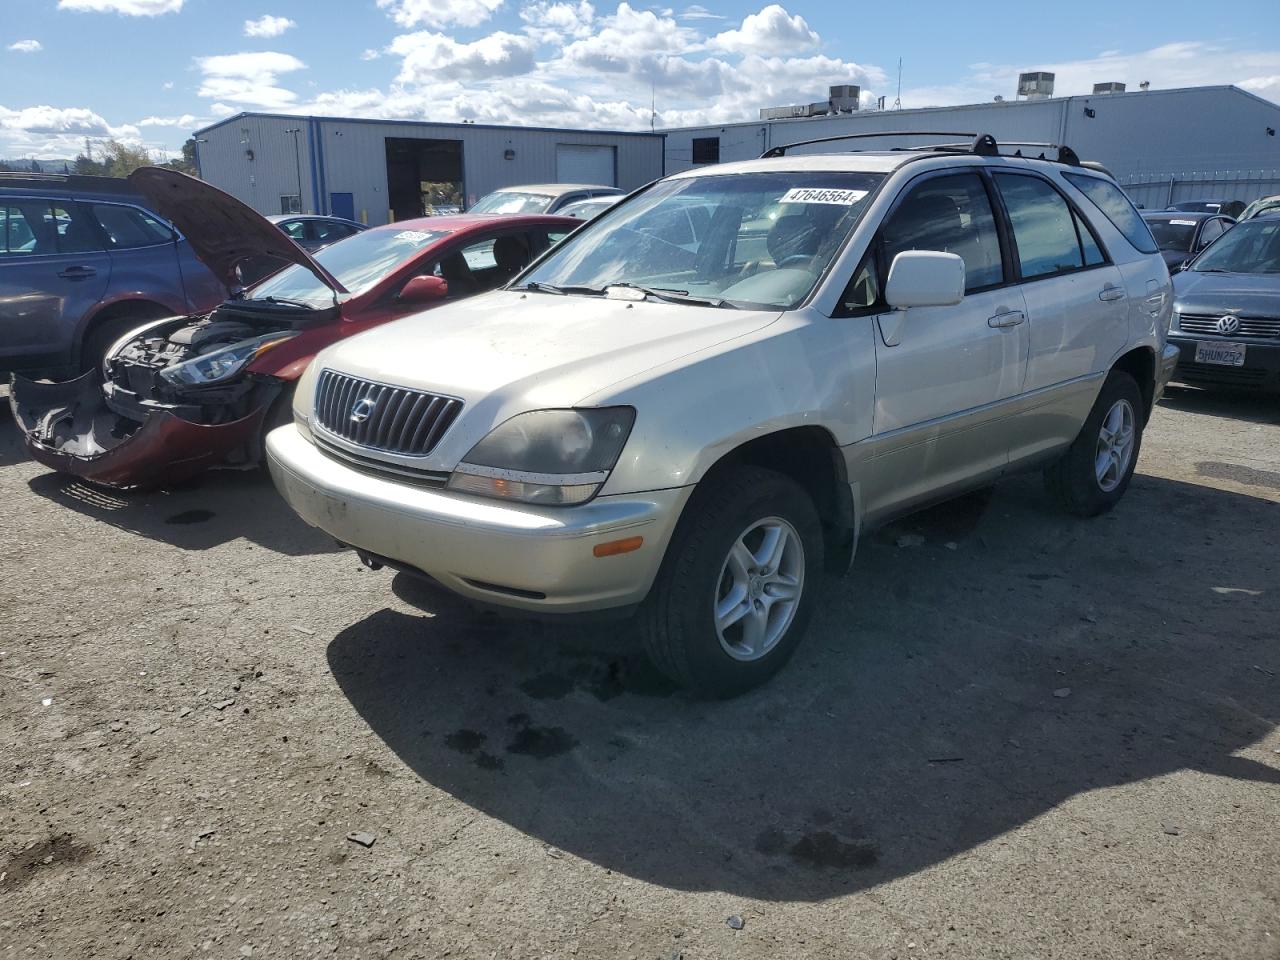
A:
[[9, 371, 266, 488]]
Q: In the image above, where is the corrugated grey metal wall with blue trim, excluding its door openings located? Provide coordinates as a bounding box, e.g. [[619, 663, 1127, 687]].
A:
[[198, 114, 663, 224]]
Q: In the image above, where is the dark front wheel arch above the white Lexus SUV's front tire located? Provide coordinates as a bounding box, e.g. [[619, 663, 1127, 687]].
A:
[[685, 426, 858, 573]]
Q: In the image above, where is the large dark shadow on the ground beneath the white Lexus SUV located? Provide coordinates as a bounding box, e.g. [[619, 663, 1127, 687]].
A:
[[328, 476, 1280, 901]]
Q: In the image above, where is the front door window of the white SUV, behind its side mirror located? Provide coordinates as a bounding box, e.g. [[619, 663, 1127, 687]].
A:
[[881, 173, 1003, 292]]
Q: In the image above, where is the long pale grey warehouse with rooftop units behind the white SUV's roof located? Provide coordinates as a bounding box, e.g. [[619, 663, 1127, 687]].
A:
[[664, 85, 1280, 209]]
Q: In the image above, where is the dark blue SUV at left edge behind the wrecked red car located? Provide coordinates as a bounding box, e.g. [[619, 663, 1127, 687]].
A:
[[0, 173, 227, 374]]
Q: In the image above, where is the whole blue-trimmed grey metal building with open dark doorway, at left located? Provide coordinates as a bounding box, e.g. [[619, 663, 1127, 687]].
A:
[[193, 113, 663, 225]]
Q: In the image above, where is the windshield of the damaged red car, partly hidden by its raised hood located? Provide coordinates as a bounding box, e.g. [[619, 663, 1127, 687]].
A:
[[250, 228, 449, 303]]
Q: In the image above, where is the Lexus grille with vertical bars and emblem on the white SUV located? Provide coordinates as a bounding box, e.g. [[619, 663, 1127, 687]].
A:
[[315, 370, 462, 457]]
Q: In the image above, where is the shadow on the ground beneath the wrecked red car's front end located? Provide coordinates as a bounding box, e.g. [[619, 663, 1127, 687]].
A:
[[27, 470, 340, 557]]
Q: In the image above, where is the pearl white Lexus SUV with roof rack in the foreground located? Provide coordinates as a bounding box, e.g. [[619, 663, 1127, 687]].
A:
[[268, 133, 1178, 696]]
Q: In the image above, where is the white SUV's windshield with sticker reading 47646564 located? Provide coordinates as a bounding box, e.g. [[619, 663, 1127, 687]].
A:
[[520, 170, 884, 310]]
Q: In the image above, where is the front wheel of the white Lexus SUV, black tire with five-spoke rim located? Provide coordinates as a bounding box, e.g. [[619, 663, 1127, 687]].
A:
[[641, 467, 823, 698]]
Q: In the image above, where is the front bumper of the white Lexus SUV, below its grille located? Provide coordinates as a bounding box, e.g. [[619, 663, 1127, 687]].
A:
[[266, 424, 692, 613]]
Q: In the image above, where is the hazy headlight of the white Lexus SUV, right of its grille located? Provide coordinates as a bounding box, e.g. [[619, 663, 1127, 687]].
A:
[[449, 407, 636, 506]]
